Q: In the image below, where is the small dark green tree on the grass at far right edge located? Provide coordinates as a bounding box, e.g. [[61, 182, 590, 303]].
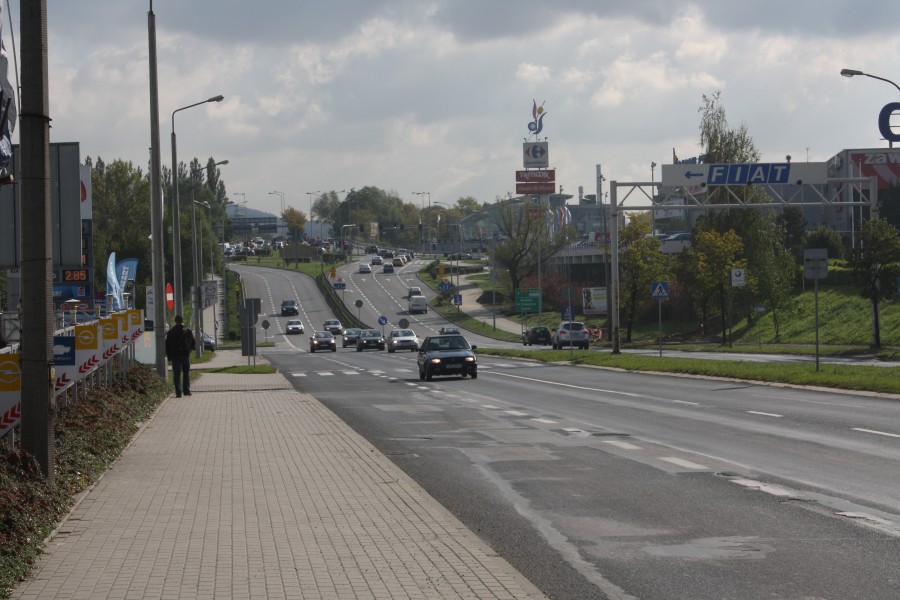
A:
[[849, 217, 900, 348]]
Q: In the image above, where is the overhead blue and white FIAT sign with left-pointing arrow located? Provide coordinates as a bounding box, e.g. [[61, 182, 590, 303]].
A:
[[661, 162, 828, 187]]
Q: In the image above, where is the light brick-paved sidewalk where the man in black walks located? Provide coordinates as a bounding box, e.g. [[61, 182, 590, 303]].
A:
[[12, 350, 543, 600]]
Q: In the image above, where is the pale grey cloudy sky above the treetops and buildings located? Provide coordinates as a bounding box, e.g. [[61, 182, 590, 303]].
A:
[[17, 0, 900, 213]]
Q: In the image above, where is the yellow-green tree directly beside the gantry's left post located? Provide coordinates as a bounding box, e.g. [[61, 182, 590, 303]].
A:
[[619, 213, 668, 342]]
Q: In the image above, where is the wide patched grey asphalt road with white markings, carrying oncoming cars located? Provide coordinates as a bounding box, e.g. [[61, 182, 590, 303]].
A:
[[230, 266, 900, 600]]
